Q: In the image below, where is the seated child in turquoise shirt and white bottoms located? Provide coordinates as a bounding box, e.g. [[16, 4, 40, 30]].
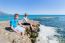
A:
[[10, 14, 25, 35]]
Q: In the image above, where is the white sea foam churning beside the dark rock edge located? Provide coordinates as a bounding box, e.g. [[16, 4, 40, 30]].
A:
[[36, 25, 59, 43]]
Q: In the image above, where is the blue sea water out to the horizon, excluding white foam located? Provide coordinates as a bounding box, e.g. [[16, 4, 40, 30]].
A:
[[0, 15, 65, 42]]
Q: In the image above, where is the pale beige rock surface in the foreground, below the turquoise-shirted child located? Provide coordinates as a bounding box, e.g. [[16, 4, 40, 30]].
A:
[[0, 29, 31, 43]]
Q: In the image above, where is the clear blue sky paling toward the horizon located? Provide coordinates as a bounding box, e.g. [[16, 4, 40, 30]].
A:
[[0, 0, 65, 14]]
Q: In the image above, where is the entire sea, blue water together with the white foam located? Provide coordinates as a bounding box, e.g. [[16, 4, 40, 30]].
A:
[[0, 15, 65, 43]]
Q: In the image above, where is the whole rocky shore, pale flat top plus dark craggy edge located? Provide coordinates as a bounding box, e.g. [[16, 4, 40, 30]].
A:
[[0, 21, 39, 43]]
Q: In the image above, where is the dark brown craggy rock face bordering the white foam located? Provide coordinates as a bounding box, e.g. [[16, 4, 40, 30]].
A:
[[26, 24, 40, 43]]
